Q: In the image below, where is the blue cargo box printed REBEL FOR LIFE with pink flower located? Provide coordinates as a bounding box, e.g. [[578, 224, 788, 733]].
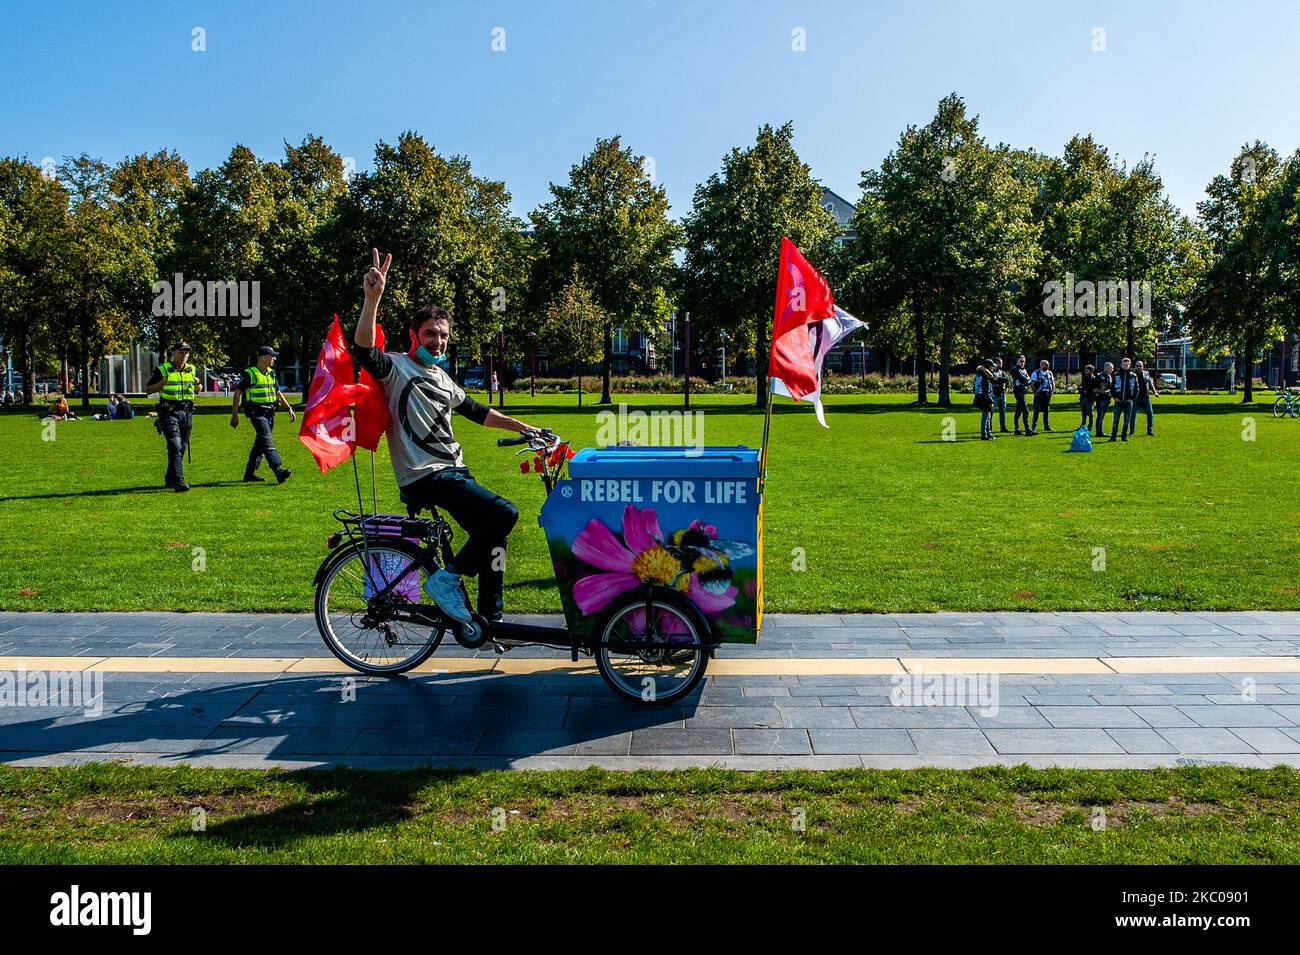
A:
[[538, 446, 763, 643]]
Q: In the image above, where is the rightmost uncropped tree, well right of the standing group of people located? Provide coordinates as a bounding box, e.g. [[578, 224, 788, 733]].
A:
[[1188, 140, 1294, 403]]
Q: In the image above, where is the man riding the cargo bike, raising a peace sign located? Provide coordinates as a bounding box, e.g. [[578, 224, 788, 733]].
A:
[[352, 249, 538, 624]]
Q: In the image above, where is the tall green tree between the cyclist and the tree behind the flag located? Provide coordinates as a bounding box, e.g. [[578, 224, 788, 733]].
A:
[[533, 136, 679, 404]]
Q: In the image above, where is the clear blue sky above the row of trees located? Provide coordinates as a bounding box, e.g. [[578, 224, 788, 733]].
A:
[[0, 0, 1300, 217]]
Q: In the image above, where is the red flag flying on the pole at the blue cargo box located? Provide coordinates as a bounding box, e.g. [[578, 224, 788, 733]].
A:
[[767, 236, 835, 400]]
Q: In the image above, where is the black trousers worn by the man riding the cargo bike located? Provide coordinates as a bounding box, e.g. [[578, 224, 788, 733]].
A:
[[402, 468, 519, 617]]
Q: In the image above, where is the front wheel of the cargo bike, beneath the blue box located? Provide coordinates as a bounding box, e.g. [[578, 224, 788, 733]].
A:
[[592, 589, 714, 703]]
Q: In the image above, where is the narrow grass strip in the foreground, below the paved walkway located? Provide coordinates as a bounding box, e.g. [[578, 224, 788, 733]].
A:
[[0, 764, 1300, 864]]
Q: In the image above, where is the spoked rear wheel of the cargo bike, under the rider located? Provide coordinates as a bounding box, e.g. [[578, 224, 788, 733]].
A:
[[316, 542, 446, 676]]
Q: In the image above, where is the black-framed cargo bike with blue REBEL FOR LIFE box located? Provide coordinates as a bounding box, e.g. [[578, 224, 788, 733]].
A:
[[315, 430, 762, 703]]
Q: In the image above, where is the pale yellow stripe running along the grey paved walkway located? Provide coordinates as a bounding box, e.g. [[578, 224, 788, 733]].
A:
[[0, 656, 1300, 677]]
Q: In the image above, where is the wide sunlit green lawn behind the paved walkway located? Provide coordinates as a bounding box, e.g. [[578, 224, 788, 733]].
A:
[[0, 392, 1300, 612]]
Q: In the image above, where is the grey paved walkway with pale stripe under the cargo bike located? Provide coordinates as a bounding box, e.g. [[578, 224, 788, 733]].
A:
[[0, 612, 1300, 769]]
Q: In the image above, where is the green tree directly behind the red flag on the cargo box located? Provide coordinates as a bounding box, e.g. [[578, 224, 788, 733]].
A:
[[683, 122, 837, 408]]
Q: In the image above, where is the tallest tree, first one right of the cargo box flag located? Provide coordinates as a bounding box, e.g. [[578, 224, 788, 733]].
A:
[[854, 94, 1040, 405]]
